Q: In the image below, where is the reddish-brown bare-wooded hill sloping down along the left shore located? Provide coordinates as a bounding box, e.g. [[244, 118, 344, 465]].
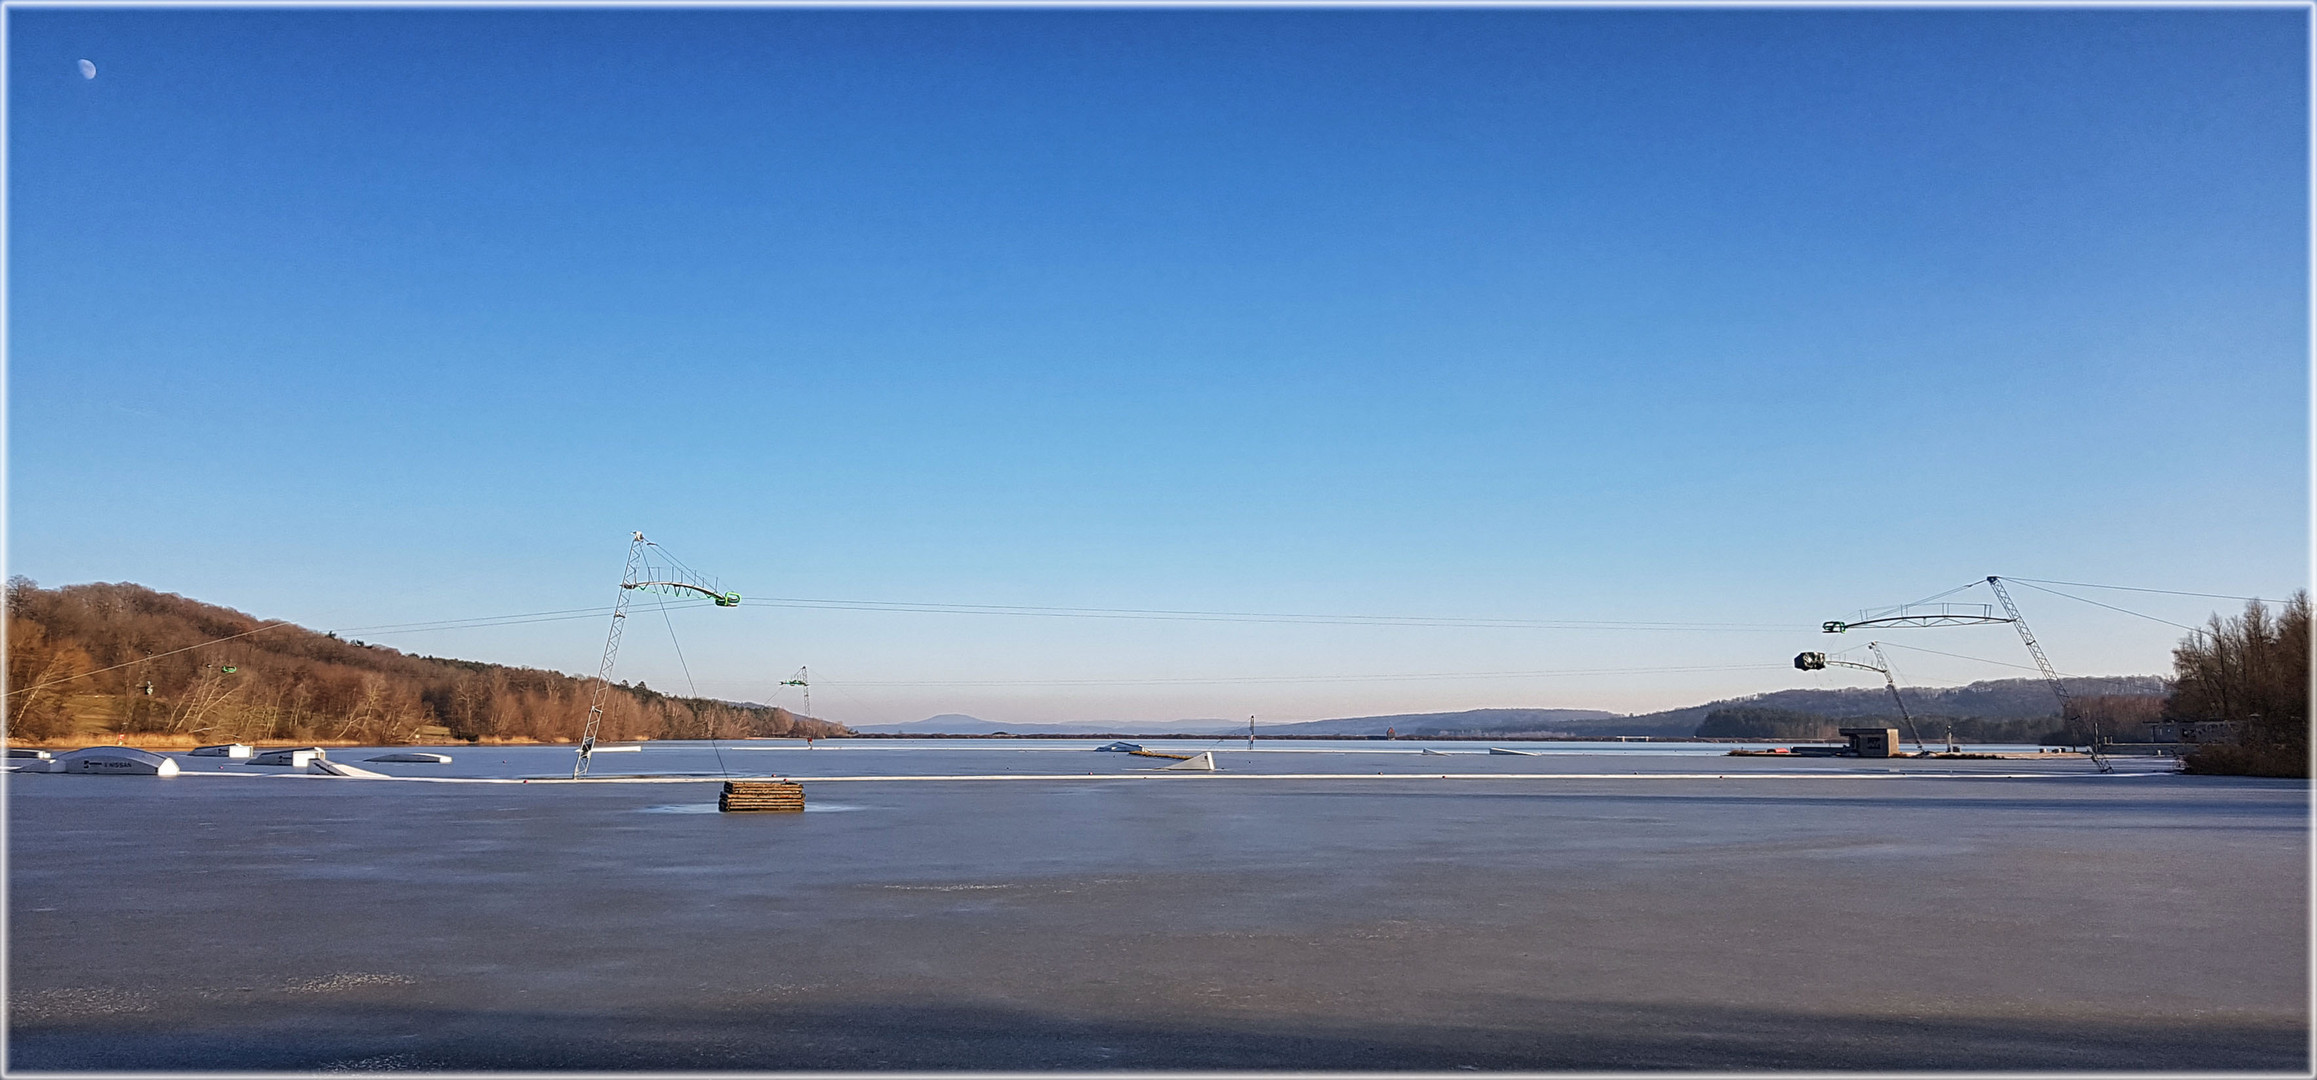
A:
[[7, 577, 846, 744]]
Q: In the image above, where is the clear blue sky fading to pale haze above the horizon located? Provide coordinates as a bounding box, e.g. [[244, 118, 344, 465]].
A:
[[7, 9, 2310, 723]]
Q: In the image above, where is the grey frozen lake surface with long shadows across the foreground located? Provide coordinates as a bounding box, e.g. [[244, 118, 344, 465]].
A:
[[7, 739, 2308, 1071]]
